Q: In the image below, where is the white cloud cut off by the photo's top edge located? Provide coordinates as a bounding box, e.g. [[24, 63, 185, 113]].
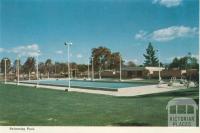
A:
[[152, 0, 182, 8]]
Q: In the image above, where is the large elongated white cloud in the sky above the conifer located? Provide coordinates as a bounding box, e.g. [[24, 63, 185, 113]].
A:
[[135, 26, 198, 42]]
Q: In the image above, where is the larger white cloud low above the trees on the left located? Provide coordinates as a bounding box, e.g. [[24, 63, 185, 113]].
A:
[[11, 44, 40, 56]]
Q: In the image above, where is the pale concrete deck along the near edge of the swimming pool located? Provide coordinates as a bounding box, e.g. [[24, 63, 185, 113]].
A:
[[7, 82, 186, 97]]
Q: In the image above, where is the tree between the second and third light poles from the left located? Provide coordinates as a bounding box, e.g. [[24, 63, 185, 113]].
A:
[[23, 57, 36, 79]]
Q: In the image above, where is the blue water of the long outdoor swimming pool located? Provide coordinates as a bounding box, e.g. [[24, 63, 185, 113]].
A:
[[22, 79, 153, 90]]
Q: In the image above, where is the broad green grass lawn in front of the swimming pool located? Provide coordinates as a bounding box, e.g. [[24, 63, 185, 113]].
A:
[[0, 84, 199, 126]]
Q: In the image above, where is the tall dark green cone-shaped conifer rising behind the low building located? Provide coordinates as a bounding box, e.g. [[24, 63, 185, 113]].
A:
[[143, 42, 159, 66]]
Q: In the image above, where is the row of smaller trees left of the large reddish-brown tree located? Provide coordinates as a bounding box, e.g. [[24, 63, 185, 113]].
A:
[[0, 57, 88, 75]]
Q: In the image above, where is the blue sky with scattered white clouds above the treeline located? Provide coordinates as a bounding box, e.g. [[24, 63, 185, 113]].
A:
[[0, 0, 199, 64]]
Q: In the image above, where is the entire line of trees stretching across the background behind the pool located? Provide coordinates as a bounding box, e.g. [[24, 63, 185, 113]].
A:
[[0, 43, 199, 76]]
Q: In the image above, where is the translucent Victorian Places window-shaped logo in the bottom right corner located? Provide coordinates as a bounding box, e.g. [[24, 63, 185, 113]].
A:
[[166, 97, 198, 126]]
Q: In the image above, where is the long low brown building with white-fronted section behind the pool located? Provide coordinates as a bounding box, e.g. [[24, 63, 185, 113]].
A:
[[99, 67, 199, 79]]
